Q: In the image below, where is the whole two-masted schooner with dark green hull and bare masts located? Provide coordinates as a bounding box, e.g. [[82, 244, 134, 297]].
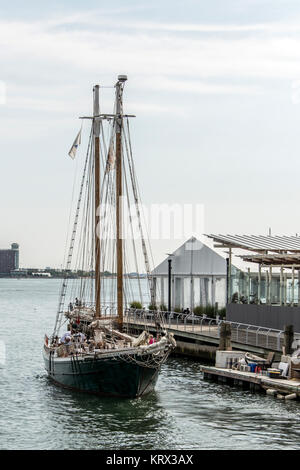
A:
[[43, 75, 176, 398]]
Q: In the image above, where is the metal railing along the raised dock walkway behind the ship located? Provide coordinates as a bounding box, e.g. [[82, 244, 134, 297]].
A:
[[125, 309, 290, 351]]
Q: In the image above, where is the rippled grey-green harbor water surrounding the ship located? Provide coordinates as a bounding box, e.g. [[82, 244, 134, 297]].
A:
[[0, 279, 300, 449]]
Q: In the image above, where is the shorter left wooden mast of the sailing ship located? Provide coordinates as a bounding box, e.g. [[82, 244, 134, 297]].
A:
[[93, 85, 101, 318]]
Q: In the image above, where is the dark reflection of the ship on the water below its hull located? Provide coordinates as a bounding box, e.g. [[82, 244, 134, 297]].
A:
[[44, 378, 172, 449]]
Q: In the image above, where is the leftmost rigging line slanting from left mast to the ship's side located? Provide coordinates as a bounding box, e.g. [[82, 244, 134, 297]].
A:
[[53, 125, 92, 337]]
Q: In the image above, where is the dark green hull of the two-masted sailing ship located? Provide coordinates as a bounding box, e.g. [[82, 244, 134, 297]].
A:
[[44, 350, 159, 398]]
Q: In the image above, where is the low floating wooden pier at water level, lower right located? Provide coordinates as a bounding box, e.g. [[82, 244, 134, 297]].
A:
[[201, 366, 300, 399]]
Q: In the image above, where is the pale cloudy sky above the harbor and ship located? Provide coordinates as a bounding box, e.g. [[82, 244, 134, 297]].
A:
[[0, 0, 300, 267]]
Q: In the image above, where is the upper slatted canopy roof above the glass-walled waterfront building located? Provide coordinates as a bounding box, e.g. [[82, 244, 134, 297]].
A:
[[206, 234, 300, 253]]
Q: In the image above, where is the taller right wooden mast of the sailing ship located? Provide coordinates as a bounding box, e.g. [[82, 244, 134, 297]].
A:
[[116, 75, 127, 330]]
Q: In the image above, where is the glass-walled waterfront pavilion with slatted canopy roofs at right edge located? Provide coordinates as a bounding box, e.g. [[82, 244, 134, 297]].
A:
[[206, 234, 300, 306]]
